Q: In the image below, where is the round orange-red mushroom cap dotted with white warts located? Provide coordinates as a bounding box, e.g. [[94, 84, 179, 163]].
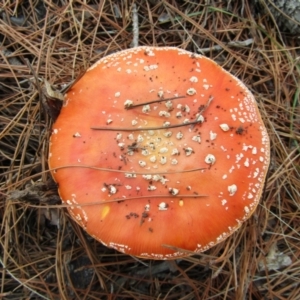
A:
[[49, 47, 270, 259]]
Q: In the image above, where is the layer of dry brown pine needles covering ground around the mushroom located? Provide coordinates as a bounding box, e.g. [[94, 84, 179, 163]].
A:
[[0, 0, 300, 299]]
